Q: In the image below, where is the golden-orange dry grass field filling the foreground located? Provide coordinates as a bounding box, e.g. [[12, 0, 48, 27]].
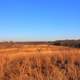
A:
[[0, 44, 80, 80]]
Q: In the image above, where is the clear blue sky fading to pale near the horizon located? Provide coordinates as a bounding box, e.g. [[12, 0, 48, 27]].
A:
[[0, 0, 80, 41]]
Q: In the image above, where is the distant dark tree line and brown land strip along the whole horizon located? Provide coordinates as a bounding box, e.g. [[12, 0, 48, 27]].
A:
[[0, 40, 80, 48]]
